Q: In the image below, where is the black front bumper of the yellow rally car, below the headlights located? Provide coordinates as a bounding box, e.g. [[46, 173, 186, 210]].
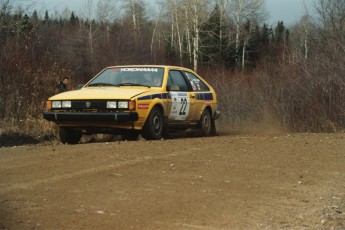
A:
[[43, 111, 138, 122]]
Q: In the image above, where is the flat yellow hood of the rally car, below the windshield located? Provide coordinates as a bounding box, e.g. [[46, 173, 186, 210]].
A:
[[49, 87, 149, 100]]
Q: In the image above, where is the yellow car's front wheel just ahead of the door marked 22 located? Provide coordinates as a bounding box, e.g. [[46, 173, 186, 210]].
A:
[[142, 106, 164, 140]]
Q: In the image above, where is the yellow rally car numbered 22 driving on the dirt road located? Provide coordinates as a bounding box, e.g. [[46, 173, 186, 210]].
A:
[[43, 65, 220, 144]]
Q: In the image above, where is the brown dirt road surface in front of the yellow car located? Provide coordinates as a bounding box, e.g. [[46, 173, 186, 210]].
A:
[[0, 134, 345, 230]]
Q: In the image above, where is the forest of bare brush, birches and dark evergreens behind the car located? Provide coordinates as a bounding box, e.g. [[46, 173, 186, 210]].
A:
[[0, 0, 345, 135]]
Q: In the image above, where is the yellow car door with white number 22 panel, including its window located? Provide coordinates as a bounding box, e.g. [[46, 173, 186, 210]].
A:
[[167, 70, 195, 124]]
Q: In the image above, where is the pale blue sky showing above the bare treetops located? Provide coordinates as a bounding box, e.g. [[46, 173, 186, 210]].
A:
[[18, 0, 317, 26]]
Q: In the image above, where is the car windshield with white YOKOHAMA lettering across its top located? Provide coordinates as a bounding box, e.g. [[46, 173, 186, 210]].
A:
[[87, 67, 164, 87]]
